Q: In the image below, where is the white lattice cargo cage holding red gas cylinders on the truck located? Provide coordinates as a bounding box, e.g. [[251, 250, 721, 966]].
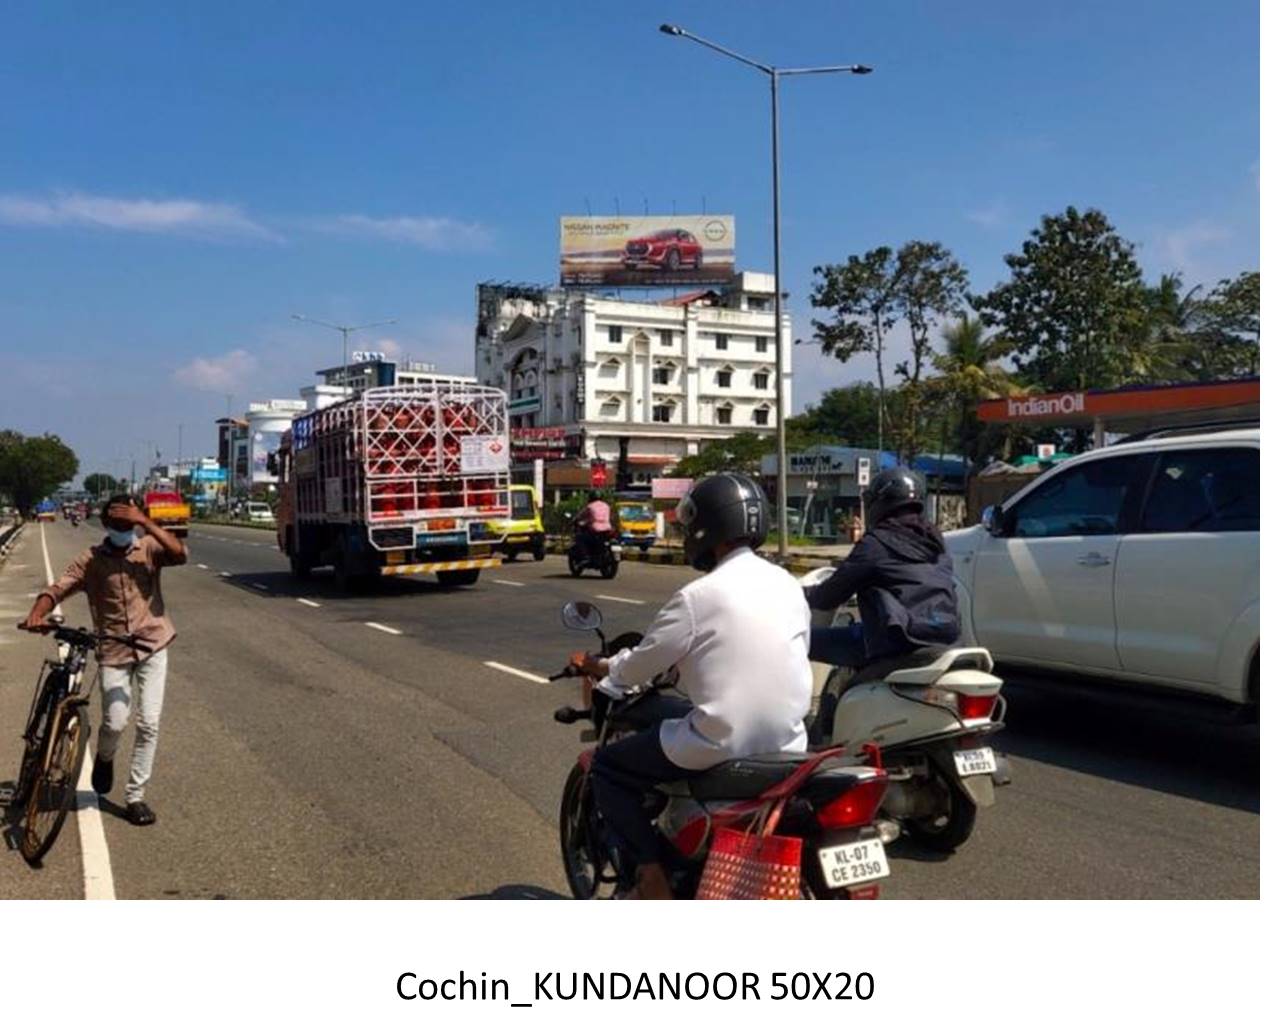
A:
[[294, 377, 510, 526]]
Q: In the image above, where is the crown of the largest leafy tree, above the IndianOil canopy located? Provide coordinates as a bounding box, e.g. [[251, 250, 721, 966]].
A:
[[971, 205, 1147, 391]]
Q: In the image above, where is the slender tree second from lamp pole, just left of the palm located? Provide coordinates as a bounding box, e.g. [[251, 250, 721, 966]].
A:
[[895, 241, 967, 458]]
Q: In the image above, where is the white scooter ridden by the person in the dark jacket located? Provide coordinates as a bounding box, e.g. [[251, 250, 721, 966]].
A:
[[800, 567, 1010, 852]]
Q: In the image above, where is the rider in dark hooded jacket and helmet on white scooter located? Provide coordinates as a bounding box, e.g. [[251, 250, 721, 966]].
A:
[[805, 467, 960, 669]]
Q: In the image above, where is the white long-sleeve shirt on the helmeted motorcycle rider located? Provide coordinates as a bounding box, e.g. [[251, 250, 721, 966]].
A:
[[603, 547, 813, 770]]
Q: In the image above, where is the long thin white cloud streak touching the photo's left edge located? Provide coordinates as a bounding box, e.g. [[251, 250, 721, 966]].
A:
[[0, 191, 279, 241]]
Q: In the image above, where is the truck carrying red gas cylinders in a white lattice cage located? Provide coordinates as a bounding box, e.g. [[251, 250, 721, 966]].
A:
[[275, 376, 510, 591]]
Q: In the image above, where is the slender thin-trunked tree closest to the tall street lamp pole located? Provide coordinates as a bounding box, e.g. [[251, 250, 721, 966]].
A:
[[809, 244, 900, 445]]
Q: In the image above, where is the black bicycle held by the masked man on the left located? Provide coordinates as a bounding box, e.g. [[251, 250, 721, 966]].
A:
[[10, 626, 144, 865]]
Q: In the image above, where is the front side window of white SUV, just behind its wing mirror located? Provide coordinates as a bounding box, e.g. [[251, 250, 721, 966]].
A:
[[1006, 455, 1139, 538]]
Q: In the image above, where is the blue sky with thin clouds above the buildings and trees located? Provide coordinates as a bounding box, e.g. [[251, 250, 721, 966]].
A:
[[0, 0, 1258, 474]]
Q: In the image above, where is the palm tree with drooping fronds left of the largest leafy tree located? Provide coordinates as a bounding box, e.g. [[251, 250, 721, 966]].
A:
[[928, 315, 1020, 462]]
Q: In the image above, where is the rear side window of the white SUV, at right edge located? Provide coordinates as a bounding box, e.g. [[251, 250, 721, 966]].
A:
[[1139, 448, 1260, 532]]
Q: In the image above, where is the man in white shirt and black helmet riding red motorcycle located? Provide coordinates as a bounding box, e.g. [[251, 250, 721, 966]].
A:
[[572, 475, 813, 899]]
